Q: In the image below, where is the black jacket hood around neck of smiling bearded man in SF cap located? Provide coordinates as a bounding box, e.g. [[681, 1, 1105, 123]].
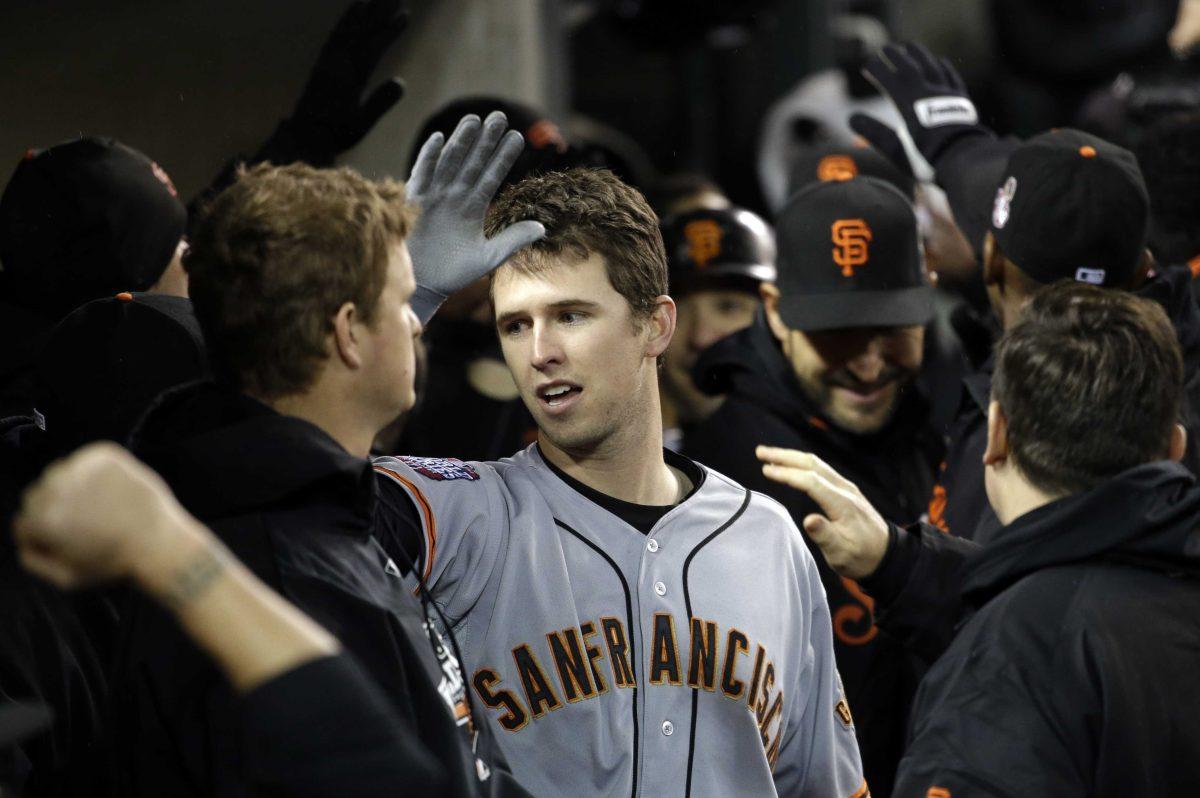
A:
[[692, 308, 929, 448]]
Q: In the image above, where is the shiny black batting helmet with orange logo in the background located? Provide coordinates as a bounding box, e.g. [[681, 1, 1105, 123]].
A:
[[662, 208, 775, 294]]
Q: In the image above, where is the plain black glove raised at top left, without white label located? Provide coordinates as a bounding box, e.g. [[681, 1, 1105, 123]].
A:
[[262, 0, 408, 167]]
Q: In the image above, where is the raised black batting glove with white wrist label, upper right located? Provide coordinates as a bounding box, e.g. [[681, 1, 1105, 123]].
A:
[[854, 43, 995, 167]]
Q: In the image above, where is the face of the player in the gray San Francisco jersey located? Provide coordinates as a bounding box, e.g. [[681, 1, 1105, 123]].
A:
[[492, 254, 659, 454]]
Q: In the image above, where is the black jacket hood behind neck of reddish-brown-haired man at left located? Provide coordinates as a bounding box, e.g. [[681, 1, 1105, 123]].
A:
[[130, 382, 374, 518]]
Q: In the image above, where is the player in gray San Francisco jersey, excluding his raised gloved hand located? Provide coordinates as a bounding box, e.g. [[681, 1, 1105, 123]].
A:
[[376, 164, 868, 798]]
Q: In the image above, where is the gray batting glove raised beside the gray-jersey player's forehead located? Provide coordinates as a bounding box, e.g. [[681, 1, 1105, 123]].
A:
[[407, 110, 546, 324]]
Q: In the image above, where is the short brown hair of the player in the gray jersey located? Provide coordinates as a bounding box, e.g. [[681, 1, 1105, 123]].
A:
[[485, 168, 667, 319]]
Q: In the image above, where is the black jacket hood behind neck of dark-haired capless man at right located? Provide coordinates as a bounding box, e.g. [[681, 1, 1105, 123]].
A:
[[962, 461, 1200, 606]]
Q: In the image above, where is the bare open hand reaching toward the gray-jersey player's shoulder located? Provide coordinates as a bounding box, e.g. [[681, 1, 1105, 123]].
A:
[[755, 446, 888, 580]]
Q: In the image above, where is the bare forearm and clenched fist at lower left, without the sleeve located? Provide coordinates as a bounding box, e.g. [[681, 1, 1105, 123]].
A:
[[13, 444, 340, 692]]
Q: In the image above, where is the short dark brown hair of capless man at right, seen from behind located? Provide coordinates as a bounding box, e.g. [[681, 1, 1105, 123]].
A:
[[991, 281, 1183, 494]]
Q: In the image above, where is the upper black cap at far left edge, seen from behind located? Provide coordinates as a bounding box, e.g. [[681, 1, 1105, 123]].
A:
[[0, 138, 187, 320]]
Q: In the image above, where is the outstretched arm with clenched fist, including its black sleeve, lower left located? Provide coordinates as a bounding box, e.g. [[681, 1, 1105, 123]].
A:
[[13, 443, 444, 798]]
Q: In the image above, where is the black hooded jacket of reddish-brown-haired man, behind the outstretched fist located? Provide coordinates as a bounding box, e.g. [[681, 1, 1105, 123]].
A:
[[112, 383, 516, 797]]
